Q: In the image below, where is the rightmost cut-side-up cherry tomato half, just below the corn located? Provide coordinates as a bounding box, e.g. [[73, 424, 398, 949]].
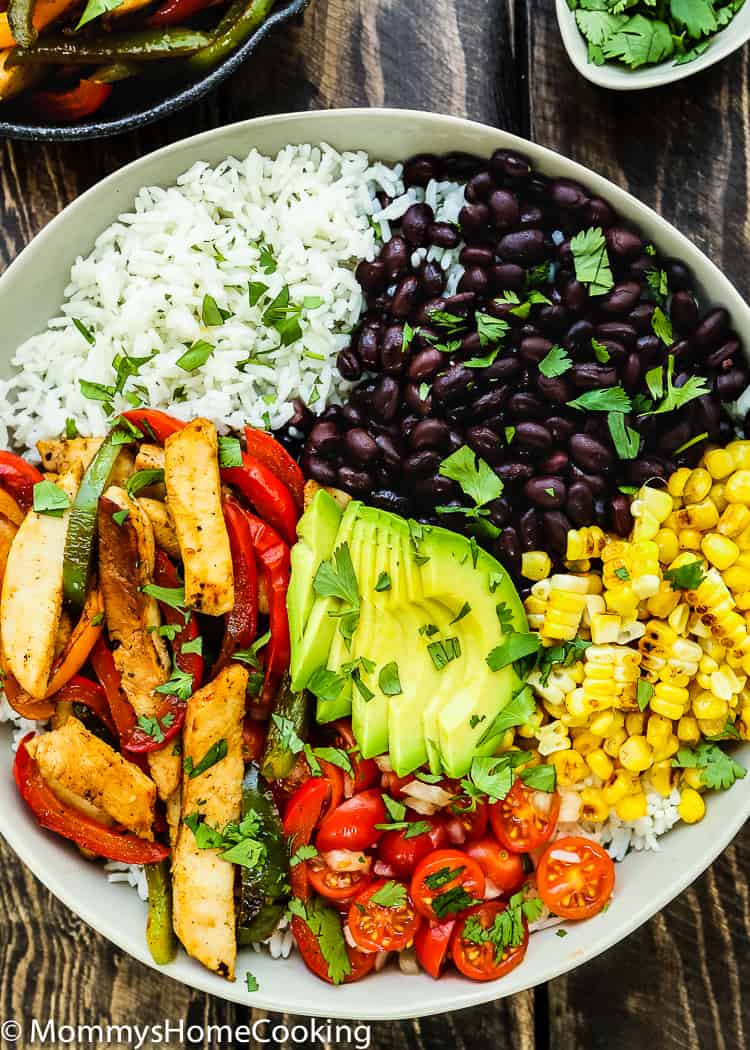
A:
[[537, 835, 614, 919]]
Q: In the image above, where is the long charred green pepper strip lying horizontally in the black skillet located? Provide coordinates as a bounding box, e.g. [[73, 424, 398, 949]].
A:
[[8, 28, 211, 66]]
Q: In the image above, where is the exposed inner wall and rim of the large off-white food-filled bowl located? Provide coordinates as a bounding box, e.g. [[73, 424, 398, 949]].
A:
[[0, 109, 750, 1020]]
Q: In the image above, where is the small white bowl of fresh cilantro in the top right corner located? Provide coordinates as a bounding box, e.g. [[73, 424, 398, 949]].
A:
[[557, 0, 750, 90]]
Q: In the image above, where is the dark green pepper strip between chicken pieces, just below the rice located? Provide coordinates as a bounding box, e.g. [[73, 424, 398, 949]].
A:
[[63, 428, 132, 612]]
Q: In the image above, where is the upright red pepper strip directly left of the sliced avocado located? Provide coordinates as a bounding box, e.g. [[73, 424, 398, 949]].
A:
[[245, 510, 291, 698]]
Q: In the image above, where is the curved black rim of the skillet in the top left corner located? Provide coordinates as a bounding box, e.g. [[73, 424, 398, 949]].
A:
[[0, 0, 311, 142]]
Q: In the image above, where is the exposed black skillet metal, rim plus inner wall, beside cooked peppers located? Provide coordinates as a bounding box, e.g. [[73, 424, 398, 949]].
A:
[[0, 0, 310, 142]]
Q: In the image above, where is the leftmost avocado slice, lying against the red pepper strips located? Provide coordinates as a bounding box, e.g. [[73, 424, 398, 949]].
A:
[[287, 488, 341, 677]]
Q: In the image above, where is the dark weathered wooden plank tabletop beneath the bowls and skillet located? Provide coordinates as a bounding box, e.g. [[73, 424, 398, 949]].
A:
[[0, 0, 750, 1050]]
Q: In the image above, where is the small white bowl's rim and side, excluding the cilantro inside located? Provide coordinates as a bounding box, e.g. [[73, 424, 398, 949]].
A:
[[556, 0, 750, 91]]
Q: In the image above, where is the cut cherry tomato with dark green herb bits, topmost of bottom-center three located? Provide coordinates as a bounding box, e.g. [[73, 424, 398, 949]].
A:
[[411, 849, 484, 922]]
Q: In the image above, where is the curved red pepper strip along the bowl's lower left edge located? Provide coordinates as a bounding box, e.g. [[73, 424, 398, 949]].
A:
[[13, 733, 169, 864]]
